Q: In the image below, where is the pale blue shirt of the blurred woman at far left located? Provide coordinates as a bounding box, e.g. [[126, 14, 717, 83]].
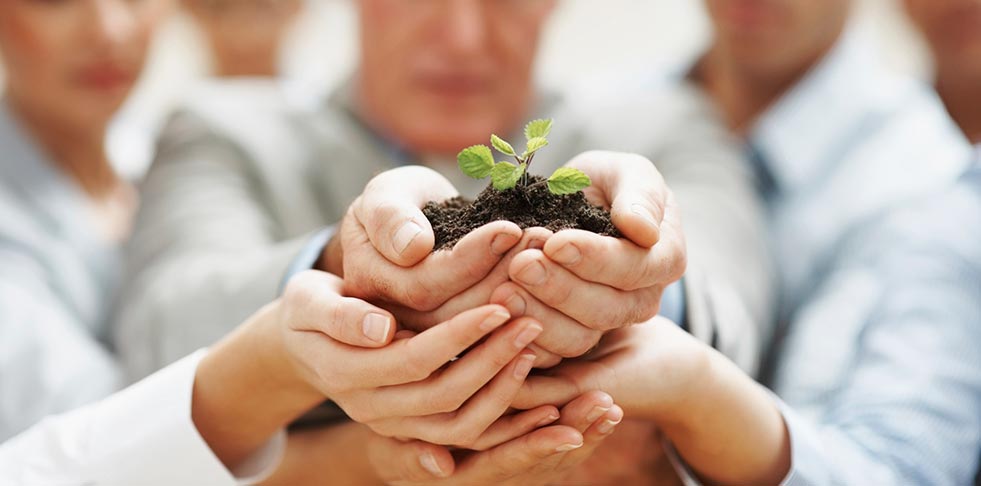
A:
[[0, 102, 120, 442]]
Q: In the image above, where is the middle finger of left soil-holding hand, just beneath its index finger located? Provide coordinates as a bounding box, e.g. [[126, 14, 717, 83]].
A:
[[388, 228, 552, 330]]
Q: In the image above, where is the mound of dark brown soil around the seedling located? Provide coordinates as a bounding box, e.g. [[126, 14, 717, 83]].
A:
[[422, 176, 622, 250]]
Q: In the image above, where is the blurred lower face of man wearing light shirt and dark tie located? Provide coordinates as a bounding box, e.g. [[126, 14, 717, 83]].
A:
[[706, 0, 848, 74]]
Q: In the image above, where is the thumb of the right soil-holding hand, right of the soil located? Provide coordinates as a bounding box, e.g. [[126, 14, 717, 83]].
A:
[[568, 151, 669, 248]]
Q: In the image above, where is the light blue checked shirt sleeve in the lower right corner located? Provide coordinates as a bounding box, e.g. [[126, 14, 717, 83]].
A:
[[777, 158, 981, 485]]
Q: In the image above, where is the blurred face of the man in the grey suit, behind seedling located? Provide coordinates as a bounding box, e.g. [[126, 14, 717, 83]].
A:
[[358, 0, 555, 154]]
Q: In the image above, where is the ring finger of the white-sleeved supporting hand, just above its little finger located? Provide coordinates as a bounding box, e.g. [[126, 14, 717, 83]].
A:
[[396, 352, 535, 449]]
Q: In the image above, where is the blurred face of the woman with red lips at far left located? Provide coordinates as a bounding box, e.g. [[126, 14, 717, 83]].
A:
[[0, 0, 169, 127]]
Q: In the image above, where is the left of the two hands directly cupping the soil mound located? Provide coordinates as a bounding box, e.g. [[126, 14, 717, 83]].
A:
[[321, 166, 522, 318]]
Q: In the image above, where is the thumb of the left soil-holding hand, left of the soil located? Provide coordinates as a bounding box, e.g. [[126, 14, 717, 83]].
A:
[[353, 166, 459, 267]]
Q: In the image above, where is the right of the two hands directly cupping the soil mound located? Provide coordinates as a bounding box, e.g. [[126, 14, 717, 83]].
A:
[[491, 152, 686, 357]]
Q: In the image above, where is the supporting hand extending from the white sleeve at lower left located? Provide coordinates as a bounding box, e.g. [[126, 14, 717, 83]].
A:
[[279, 271, 558, 450]]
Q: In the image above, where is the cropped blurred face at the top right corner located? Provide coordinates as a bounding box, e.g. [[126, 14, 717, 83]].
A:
[[906, 0, 981, 79]]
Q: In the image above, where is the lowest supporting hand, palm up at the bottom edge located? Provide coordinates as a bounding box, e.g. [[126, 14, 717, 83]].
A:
[[368, 392, 623, 486]]
